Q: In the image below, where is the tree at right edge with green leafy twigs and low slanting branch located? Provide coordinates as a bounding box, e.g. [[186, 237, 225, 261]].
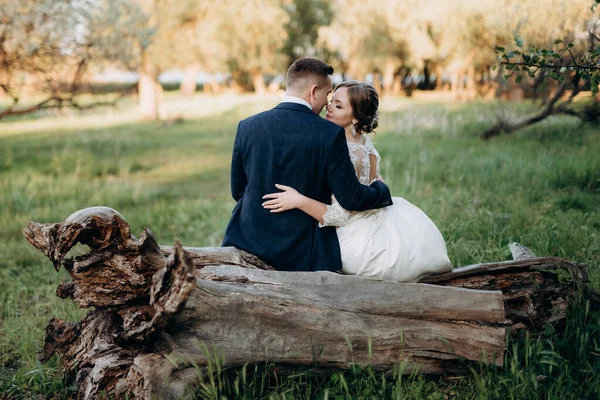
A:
[[482, 0, 600, 139]]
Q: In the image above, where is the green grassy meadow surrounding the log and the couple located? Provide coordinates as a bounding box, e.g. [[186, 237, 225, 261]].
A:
[[0, 96, 600, 399]]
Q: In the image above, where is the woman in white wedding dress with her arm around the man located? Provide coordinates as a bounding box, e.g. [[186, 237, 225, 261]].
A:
[[263, 81, 452, 282]]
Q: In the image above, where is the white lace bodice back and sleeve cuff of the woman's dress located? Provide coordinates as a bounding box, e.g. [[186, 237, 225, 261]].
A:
[[319, 137, 381, 227]]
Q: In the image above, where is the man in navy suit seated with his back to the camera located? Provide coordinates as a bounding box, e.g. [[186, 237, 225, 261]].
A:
[[223, 58, 392, 271]]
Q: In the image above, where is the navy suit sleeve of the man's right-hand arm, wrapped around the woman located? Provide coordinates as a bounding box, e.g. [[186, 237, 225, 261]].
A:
[[327, 129, 392, 211]]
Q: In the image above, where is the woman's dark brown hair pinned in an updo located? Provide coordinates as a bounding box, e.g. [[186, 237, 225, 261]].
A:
[[335, 81, 379, 133]]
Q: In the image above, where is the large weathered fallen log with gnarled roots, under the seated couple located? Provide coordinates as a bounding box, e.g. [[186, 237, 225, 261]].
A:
[[24, 207, 586, 398]]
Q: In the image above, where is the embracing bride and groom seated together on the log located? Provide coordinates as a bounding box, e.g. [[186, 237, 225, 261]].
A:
[[223, 58, 452, 282]]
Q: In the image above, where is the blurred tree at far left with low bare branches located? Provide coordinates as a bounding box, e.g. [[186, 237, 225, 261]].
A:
[[0, 0, 151, 118]]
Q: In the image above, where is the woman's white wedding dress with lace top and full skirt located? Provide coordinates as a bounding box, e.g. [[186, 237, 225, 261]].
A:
[[319, 138, 452, 282]]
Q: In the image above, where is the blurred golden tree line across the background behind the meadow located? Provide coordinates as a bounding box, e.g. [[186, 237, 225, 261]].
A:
[[0, 0, 598, 118]]
